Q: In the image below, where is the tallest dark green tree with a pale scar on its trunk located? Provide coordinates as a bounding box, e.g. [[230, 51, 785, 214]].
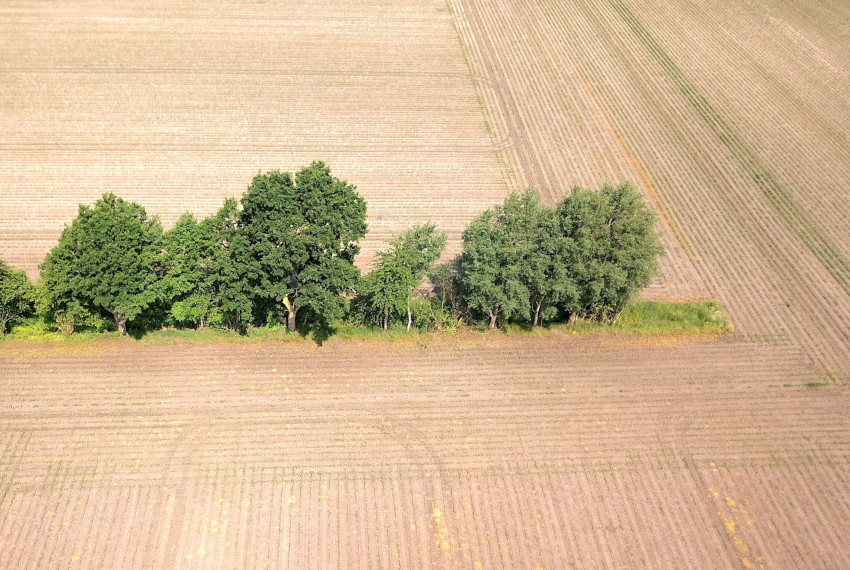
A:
[[242, 162, 366, 330]]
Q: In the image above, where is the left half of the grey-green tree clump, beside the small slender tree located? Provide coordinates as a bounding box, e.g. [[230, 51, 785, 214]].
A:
[[459, 191, 541, 328]]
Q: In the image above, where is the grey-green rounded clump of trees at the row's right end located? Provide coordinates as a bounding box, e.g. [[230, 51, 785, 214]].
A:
[[459, 184, 662, 328]]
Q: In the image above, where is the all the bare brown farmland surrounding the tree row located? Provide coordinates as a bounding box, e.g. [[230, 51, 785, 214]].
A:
[[0, 0, 850, 568]]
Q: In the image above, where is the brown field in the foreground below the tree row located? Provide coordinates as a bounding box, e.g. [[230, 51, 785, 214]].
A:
[[0, 335, 850, 568]]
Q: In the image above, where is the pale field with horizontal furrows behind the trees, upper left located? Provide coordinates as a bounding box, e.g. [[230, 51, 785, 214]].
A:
[[0, 0, 506, 276]]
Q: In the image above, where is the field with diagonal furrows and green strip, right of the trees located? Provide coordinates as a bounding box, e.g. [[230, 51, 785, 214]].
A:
[[451, 0, 850, 372]]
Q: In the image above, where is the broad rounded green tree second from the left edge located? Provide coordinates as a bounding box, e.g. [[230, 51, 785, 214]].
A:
[[41, 193, 162, 336]]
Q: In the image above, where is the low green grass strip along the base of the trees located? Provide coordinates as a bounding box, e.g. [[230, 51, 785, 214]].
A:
[[6, 301, 732, 346]]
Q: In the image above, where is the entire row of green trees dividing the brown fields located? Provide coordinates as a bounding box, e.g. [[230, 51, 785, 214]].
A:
[[0, 162, 661, 335]]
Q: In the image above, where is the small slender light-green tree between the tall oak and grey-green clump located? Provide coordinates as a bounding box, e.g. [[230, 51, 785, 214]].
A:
[[358, 223, 446, 330]]
